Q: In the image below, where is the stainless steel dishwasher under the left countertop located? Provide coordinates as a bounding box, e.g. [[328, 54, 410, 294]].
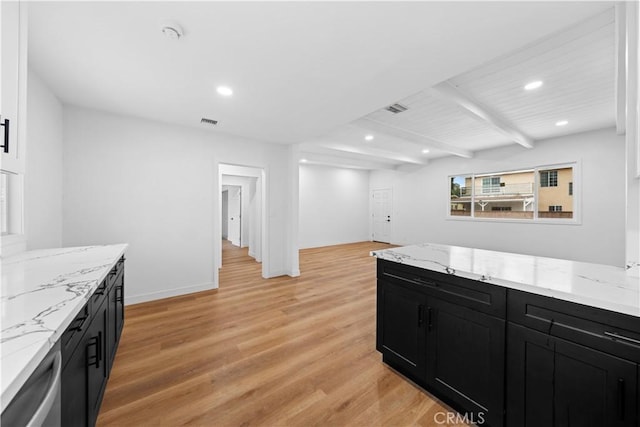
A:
[[0, 341, 62, 427]]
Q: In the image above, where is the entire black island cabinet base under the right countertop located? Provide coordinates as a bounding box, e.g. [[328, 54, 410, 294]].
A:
[[376, 259, 640, 427]]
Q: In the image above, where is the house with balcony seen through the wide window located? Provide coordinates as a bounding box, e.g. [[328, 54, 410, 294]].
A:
[[449, 166, 574, 220]]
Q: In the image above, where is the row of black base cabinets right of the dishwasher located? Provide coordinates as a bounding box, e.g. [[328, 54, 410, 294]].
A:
[[61, 259, 124, 427]]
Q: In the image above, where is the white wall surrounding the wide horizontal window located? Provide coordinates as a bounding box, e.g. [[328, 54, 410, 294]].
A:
[[370, 129, 625, 266]]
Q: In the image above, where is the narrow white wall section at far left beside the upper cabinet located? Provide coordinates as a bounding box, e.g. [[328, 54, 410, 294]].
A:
[[24, 70, 63, 250]]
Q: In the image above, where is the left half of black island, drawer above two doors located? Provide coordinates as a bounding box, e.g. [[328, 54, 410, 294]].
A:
[[376, 260, 506, 427]]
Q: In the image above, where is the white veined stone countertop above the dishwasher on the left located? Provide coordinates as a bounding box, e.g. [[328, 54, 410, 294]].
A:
[[0, 244, 128, 407]]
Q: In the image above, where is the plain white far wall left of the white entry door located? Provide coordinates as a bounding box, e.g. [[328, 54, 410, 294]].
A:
[[298, 164, 371, 249]]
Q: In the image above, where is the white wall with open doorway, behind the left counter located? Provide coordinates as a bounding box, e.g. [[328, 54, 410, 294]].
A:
[[63, 107, 291, 303]]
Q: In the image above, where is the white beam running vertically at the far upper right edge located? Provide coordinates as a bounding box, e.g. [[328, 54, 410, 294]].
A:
[[615, 2, 627, 135]]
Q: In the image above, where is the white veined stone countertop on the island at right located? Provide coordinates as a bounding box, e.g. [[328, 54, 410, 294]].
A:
[[371, 243, 640, 317]]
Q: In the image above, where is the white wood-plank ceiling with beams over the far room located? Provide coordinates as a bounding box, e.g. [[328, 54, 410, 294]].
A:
[[301, 6, 618, 169]]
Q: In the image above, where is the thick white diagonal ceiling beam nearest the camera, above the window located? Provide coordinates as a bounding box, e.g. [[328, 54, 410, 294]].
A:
[[431, 81, 534, 148]]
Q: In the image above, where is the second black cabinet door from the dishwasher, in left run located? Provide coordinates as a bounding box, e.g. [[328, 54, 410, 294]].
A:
[[85, 299, 108, 425]]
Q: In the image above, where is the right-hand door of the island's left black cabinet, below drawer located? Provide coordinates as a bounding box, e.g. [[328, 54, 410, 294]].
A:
[[426, 298, 505, 427]]
